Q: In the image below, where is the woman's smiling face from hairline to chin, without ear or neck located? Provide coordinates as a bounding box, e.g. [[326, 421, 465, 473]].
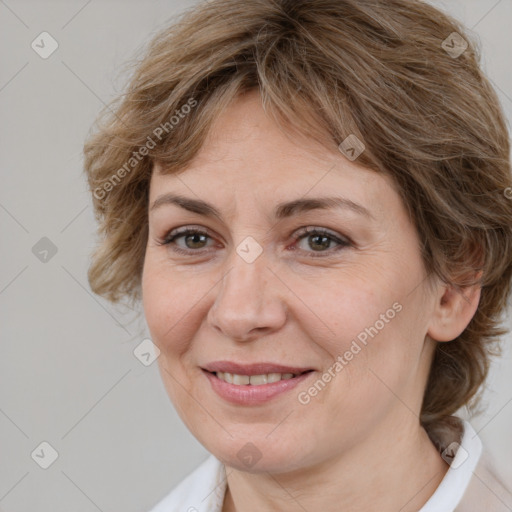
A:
[[143, 94, 440, 472]]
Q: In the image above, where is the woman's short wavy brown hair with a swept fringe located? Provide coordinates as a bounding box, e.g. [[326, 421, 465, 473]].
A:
[[85, 0, 512, 425]]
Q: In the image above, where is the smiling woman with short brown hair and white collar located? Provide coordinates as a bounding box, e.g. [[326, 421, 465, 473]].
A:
[[85, 0, 512, 512]]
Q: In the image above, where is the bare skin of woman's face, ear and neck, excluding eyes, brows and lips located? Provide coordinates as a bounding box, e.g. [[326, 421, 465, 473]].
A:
[[143, 93, 480, 512]]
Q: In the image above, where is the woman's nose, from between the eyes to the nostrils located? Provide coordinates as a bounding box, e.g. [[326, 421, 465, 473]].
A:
[[208, 246, 287, 341]]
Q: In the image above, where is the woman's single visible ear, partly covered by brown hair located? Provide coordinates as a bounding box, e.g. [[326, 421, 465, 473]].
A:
[[427, 271, 482, 341]]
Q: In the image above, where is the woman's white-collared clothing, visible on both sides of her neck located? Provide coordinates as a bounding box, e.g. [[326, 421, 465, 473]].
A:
[[150, 420, 512, 512]]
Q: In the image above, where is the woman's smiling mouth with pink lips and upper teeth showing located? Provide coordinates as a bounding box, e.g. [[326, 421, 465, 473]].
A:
[[201, 361, 315, 405]]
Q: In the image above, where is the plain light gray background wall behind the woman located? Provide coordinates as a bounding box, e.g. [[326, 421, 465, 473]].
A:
[[0, 0, 512, 512]]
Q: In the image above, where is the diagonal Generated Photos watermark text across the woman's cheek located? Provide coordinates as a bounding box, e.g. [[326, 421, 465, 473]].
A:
[[297, 302, 403, 405]]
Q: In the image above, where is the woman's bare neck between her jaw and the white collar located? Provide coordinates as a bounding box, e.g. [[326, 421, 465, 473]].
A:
[[222, 420, 448, 512]]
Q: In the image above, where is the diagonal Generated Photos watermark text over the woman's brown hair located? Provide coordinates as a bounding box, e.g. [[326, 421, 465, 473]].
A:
[[93, 98, 197, 200]]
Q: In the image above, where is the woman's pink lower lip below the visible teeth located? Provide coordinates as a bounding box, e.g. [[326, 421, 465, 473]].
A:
[[203, 370, 314, 405]]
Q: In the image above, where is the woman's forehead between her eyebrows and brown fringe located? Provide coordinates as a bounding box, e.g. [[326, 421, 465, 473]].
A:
[[150, 90, 396, 222]]
